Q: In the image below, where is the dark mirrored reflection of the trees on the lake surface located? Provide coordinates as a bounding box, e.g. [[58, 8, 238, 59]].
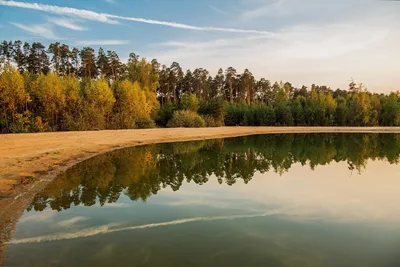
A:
[[28, 134, 400, 211]]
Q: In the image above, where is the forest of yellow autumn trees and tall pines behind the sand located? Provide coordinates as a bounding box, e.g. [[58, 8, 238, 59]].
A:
[[0, 41, 400, 133]]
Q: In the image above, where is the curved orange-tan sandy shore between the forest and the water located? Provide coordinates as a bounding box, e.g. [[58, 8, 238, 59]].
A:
[[0, 127, 400, 263]]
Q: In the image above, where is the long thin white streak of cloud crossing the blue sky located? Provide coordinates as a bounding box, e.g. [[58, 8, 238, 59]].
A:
[[0, 0, 271, 35]]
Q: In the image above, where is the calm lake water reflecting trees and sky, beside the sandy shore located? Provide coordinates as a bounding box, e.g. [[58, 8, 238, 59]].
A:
[[5, 134, 400, 267]]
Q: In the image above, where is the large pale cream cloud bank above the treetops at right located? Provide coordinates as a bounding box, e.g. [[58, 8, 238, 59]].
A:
[[149, 18, 400, 91]]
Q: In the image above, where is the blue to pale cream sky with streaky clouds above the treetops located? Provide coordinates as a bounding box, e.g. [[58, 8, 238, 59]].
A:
[[0, 0, 400, 92]]
